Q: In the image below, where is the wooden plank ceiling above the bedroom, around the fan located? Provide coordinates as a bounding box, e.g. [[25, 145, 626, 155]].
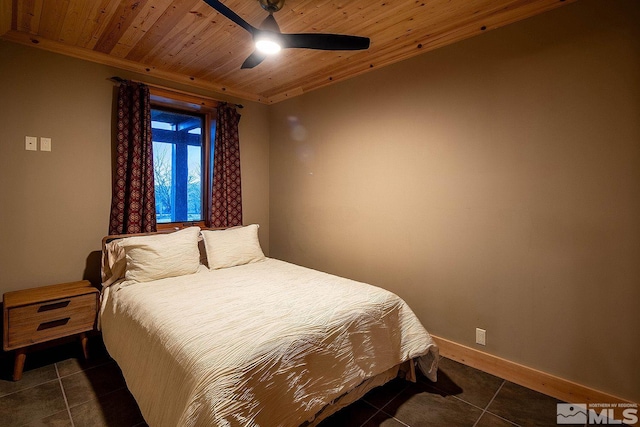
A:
[[0, 0, 573, 104]]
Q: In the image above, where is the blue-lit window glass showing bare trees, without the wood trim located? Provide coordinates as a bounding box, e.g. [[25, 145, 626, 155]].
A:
[[151, 109, 203, 223]]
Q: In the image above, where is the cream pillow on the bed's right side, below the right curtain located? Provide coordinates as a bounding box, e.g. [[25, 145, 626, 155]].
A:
[[202, 224, 265, 269]]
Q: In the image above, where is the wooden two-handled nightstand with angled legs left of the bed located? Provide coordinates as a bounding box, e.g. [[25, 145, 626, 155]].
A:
[[3, 280, 99, 381]]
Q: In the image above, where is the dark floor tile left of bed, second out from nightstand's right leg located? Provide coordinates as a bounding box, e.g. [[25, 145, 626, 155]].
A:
[[61, 362, 126, 407]]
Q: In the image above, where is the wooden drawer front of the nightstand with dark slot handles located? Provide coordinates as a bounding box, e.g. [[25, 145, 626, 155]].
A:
[[7, 293, 97, 350]]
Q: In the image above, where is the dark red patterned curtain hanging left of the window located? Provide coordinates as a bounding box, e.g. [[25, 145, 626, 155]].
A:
[[109, 81, 156, 234]]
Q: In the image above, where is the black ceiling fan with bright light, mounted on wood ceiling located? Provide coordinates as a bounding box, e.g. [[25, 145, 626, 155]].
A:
[[204, 0, 370, 68]]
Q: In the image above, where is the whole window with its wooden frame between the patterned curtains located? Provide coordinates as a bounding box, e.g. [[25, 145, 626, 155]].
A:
[[151, 88, 215, 229]]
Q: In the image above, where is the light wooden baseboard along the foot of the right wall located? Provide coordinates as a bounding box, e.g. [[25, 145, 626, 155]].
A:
[[432, 335, 634, 403]]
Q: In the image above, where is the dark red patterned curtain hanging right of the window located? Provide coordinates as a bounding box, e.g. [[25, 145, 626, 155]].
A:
[[210, 104, 242, 227]]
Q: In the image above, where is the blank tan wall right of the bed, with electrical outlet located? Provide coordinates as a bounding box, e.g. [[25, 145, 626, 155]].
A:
[[270, 0, 640, 402]]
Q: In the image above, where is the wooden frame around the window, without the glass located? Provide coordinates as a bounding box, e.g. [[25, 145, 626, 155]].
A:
[[149, 86, 219, 230]]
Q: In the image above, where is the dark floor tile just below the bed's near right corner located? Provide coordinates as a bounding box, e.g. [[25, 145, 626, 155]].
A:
[[382, 383, 482, 427]]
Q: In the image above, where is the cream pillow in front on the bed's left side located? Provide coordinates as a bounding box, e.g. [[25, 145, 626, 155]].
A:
[[118, 227, 200, 282]]
